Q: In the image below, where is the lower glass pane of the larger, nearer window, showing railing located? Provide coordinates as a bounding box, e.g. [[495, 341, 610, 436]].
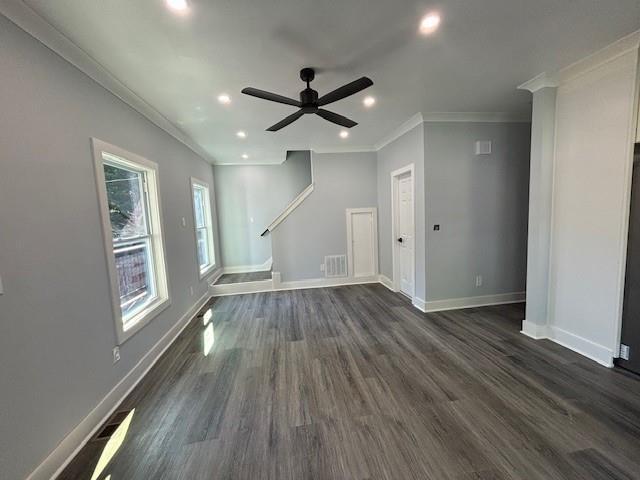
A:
[[114, 240, 156, 323]]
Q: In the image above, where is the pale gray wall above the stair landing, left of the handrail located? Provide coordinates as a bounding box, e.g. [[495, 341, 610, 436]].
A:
[[214, 151, 311, 267]]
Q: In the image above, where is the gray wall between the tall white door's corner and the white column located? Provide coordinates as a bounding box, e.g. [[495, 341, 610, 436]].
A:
[[424, 123, 530, 301]]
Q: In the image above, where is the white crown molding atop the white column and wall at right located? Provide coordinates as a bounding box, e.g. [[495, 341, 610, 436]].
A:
[[518, 30, 640, 92]]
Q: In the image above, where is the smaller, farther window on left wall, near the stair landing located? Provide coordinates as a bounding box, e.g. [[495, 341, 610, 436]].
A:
[[191, 178, 216, 279]]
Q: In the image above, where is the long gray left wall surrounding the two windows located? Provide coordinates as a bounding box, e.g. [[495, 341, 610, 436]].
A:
[[0, 16, 219, 480]]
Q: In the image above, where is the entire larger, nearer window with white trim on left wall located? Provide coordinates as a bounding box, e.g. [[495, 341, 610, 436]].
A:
[[93, 139, 169, 343]]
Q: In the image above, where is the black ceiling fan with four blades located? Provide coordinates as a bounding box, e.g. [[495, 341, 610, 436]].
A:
[[242, 68, 373, 132]]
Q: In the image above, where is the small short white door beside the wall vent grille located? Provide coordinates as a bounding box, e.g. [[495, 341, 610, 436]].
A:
[[347, 208, 378, 278]]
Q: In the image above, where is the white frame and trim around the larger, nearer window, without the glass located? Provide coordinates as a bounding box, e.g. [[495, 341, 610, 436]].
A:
[[91, 138, 171, 345]]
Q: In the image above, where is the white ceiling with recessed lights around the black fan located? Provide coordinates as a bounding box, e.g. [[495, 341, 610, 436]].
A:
[[15, 0, 640, 163]]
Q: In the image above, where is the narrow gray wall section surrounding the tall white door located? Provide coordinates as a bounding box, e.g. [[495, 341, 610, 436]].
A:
[[377, 125, 426, 300]]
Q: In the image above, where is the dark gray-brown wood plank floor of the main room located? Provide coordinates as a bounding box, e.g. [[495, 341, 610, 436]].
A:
[[61, 285, 640, 480]]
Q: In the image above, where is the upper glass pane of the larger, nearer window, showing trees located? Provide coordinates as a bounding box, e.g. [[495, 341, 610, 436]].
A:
[[104, 163, 148, 240]]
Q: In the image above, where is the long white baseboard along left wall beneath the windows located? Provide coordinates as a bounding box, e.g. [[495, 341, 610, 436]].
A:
[[27, 292, 210, 480]]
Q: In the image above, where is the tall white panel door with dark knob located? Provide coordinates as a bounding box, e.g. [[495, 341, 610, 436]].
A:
[[394, 171, 415, 297]]
